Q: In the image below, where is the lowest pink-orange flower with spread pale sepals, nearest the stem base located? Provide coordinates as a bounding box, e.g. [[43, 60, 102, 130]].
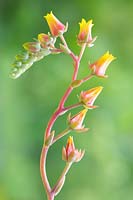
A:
[[62, 136, 85, 162]]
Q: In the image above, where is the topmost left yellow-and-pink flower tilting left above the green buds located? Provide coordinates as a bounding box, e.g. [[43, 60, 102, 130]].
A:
[[44, 11, 66, 37]]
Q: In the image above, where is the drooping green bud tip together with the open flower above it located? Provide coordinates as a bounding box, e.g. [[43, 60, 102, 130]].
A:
[[10, 12, 67, 79]]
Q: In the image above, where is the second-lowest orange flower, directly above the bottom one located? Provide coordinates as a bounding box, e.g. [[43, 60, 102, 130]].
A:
[[68, 109, 88, 131]]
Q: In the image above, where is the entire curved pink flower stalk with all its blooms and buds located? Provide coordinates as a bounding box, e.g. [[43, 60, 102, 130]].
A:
[[10, 12, 116, 199]]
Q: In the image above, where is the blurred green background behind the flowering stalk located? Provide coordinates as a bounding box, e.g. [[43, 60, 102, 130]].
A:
[[0, 0, 133, 200]]
